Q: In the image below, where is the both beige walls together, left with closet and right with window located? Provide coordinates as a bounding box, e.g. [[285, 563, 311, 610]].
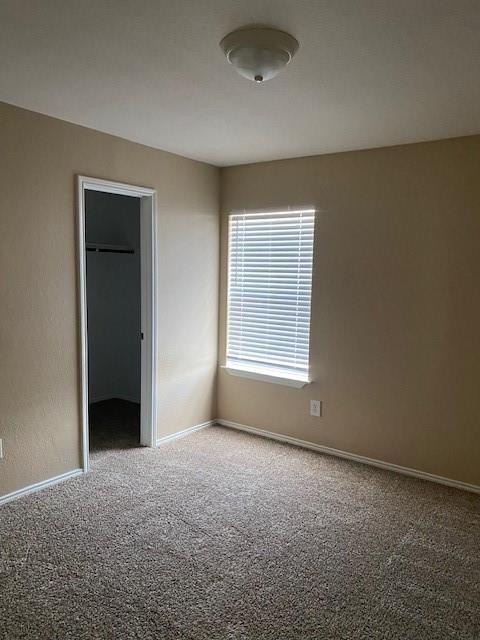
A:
[[0, 104, 480, 495]]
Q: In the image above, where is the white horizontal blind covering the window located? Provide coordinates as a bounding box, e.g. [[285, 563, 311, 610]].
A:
[[227, 209, 315, 380]]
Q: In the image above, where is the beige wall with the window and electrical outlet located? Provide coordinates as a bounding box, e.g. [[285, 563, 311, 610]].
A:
[[218, 136, 480, 485]]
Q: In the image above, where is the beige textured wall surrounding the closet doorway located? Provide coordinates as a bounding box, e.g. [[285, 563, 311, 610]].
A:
[[0, 104, 218, 495]]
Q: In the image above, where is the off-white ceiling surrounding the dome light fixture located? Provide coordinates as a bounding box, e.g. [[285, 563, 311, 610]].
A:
[[0, 0, 480, 166]]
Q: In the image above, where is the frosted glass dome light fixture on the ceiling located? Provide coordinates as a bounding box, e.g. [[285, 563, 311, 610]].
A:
[[220, 27, 299, 83]]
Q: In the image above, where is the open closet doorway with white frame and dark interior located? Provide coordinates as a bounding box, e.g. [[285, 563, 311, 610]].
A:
[[78, 176, 156, 471]]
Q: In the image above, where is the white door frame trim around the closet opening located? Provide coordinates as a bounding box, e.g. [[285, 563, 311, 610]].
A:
[[77, 175, 157, 473]]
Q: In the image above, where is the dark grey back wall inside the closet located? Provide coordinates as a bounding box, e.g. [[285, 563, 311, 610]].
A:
[[85, 191, 141, 402]]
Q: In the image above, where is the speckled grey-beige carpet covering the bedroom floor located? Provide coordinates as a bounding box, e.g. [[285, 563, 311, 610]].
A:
[[0, 427, 480, 640]]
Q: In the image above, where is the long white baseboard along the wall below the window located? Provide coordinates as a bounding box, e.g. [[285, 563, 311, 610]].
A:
[[214, 419, 480, 493]]
